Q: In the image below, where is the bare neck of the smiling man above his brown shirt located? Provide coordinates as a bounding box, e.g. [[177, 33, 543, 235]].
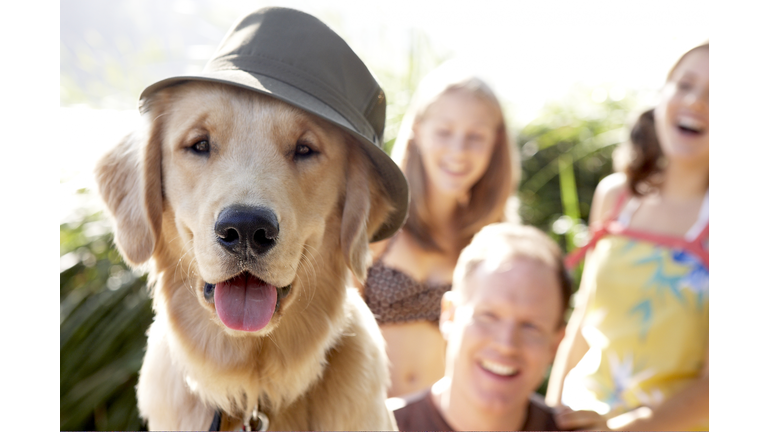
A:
[[429, 377, 528, 431]]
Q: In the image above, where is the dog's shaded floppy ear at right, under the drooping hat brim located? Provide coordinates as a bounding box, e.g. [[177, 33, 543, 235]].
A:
[[341, 141, 392, 283]]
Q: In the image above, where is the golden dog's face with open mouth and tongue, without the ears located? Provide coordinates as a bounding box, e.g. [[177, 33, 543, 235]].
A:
[[162, 82, 354, 331]]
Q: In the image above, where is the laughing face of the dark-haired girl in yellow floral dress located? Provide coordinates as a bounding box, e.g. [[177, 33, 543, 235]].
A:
[[654, 48, 709, 165]]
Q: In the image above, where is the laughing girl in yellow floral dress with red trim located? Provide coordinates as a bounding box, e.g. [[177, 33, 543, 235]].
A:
[[547, 44, 709, 430]]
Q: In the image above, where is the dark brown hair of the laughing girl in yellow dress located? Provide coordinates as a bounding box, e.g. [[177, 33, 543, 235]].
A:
[[614, 42, 709, 195]]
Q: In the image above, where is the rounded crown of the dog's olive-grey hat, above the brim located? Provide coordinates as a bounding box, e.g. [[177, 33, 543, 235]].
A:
[[203, 7, 386, 146]]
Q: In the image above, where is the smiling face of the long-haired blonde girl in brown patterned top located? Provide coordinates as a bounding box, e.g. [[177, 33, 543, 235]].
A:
[[413, 90, 501, 199]]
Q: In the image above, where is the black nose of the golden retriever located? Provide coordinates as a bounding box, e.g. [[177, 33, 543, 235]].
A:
[[213, 205, 280, 255]]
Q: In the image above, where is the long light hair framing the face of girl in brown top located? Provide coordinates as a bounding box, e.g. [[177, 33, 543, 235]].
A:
[[392, 63, 521, 252]]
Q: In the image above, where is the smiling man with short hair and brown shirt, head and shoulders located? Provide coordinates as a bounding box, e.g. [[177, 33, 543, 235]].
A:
[[388, 223, 571, 431]]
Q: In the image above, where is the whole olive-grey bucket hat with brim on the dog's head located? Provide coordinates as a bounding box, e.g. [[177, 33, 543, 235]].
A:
[[139, 7, 410, 242]]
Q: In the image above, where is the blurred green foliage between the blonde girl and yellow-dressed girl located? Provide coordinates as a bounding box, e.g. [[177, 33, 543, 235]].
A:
[[518, 89, 634, 252]]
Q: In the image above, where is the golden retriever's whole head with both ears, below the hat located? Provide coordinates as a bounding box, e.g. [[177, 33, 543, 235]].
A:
[[96, 82, 392, 335]]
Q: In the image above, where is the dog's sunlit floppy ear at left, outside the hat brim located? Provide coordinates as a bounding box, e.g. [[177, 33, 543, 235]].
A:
[[95, 109, 163, 265]]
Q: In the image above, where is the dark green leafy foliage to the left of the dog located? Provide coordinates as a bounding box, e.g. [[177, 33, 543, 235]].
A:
[[59, 214, 152, 430]]
